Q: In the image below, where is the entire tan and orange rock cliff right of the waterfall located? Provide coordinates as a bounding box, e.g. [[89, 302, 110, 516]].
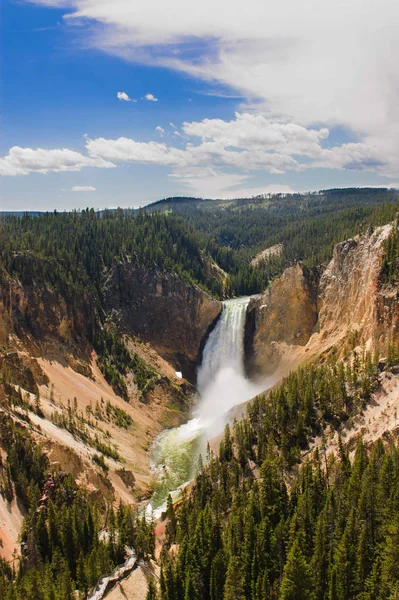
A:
[[246, 225, 399, 374]]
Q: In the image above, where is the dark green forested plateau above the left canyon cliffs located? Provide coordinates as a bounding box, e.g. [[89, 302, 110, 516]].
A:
[[0, 210, 217, 300]]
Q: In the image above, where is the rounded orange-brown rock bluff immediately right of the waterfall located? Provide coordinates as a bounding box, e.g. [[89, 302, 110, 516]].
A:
[[245, 263, 318, 376]]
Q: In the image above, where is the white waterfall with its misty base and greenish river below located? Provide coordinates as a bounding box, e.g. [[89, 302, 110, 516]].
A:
[[149, 298, 266, 515]]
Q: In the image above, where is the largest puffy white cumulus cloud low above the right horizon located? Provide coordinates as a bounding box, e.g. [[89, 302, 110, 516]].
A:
[[86, 113, 390, 183]]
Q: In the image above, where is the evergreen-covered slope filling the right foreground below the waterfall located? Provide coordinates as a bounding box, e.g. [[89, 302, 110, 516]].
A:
[[161, 349, 399, 600]]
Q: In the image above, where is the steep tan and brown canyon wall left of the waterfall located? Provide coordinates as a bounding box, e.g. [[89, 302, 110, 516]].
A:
[[0, 254, 221, 559]]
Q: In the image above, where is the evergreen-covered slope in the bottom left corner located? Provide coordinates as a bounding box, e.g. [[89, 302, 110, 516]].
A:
[[0, 406, 154, 600]]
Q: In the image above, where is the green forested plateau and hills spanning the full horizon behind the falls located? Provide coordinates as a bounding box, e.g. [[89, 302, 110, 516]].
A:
[[0, 188, 398, 298]]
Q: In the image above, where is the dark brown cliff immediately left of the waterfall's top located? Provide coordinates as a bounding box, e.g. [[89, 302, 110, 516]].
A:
[[104, 263, 222, 381]]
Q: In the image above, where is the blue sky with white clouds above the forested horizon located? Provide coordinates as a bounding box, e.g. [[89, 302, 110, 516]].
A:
[[0, 0, 399, 210]]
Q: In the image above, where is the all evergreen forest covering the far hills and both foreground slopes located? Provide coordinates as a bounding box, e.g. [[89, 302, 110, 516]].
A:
[[0, 189, 399, 600]]
